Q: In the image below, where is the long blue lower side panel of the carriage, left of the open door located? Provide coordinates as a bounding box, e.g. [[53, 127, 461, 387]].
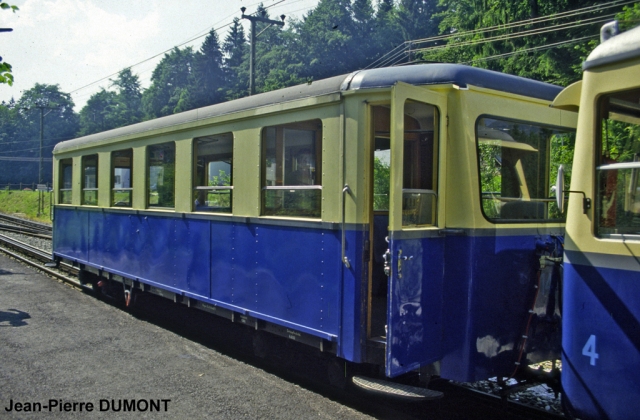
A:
[[54, 207, 364, 361]]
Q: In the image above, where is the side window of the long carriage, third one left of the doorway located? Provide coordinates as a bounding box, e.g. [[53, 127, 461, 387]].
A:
[[147, 142, 176, 208]]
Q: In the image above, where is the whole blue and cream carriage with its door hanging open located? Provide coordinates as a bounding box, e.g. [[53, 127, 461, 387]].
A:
[[54, 64, 576, 388]]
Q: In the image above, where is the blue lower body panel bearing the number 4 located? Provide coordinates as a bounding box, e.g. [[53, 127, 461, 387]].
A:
[[562, 257, 640, 419]]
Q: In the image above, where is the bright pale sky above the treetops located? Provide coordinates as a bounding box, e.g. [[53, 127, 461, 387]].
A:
[[0, 0, 319, 112]]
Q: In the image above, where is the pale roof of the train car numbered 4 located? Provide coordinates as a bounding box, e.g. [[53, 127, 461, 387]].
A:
[[582, 26, 640, 70]]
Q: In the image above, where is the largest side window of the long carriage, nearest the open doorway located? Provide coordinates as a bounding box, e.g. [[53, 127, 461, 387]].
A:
[[262, 120, 322, 217]]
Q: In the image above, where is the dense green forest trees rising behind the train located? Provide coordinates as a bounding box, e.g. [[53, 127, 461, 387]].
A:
[[0, 0, 640, 182]]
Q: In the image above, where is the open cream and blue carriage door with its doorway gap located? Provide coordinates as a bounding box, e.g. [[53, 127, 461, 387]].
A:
[[369, 83, 446, 377]]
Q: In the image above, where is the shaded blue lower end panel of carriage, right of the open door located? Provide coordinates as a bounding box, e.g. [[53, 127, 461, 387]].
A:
[[441, 234, 561, 382]]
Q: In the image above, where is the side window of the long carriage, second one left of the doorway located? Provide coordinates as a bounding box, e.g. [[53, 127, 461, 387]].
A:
[[193, 133, 233, 213]]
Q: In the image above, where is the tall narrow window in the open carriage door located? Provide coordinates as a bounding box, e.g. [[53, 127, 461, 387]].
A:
[[402, 101, 438, 227]]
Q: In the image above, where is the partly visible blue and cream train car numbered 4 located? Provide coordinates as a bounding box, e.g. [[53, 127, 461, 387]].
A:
[[554, 25, 640, 419]]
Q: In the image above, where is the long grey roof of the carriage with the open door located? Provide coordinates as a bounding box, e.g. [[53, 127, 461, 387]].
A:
[[53, 63, 562, 154]]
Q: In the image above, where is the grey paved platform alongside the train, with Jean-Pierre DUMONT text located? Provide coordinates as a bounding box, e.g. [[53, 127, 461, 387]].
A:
[[0, 254, 370, 420]]
